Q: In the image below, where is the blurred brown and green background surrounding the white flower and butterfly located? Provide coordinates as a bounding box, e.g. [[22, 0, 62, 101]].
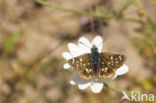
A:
[[0, 0, 156, 103]]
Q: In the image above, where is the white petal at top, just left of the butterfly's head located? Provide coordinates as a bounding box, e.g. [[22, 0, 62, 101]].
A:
[[78, 37, 91, 53]]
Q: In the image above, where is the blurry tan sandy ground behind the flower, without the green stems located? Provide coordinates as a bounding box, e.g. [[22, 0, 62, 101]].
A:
[[0, 0, 156, 103]]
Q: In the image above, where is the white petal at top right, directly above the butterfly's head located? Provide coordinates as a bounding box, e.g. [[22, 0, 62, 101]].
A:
[[92, 36, 103, 52]]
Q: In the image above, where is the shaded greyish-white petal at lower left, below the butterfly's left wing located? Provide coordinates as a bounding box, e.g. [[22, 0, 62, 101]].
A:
[[70, 74, 92, 85]]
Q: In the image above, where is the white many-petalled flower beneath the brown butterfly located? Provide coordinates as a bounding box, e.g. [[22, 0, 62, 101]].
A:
[[62, 36, 128, 93]]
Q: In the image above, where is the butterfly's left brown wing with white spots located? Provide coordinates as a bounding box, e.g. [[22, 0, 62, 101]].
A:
[[68, 53, 95, 79]]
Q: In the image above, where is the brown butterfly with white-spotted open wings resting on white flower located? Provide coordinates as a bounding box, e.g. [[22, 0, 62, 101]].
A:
[[68, 45, 126, 80]]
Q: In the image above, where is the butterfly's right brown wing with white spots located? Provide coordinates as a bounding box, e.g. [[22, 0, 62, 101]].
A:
[[98, 53, 126, 78]]
